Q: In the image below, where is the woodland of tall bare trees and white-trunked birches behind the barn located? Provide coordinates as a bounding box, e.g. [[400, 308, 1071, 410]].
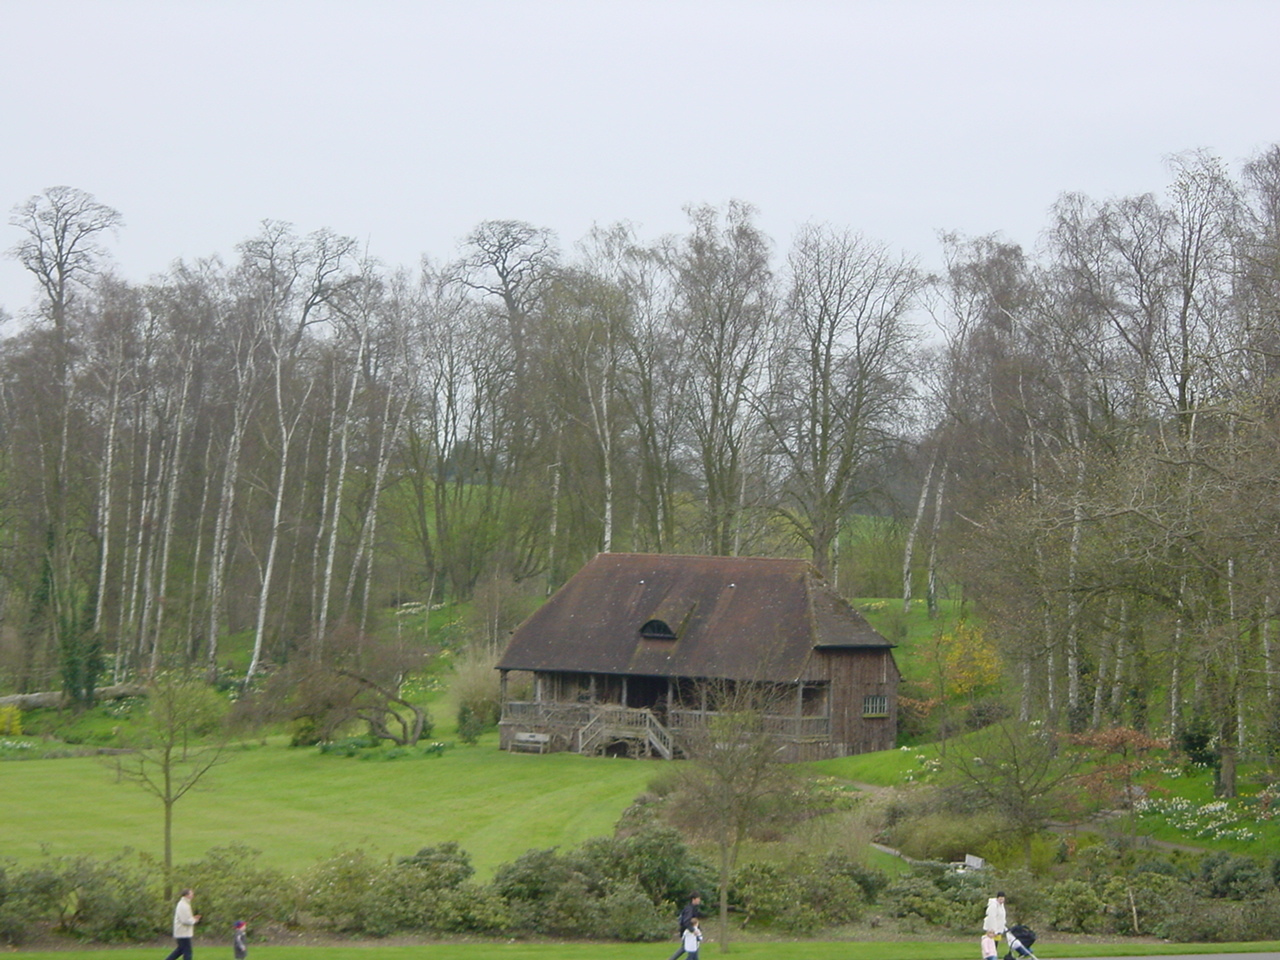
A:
[[0, 147, 1280, 771]]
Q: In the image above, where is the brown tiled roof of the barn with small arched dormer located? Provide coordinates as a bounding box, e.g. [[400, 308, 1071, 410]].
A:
[[498, 553, 891, 681]]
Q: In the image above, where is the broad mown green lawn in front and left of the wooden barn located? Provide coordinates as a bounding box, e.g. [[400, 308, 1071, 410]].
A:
[[0, 733, 658, 878]]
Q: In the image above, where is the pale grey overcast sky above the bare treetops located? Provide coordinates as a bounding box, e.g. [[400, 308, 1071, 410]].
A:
[[0, 0, 1280, 320]]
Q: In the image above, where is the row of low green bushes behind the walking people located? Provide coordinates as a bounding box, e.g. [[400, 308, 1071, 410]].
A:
[[0, 823, 1280, 945]]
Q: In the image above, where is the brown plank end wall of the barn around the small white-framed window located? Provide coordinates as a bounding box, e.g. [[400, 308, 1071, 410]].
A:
[[818, 648, 900, 754]]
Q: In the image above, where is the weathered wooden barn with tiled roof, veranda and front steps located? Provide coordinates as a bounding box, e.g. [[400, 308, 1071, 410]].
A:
[[498, 553, 899, 760]]
